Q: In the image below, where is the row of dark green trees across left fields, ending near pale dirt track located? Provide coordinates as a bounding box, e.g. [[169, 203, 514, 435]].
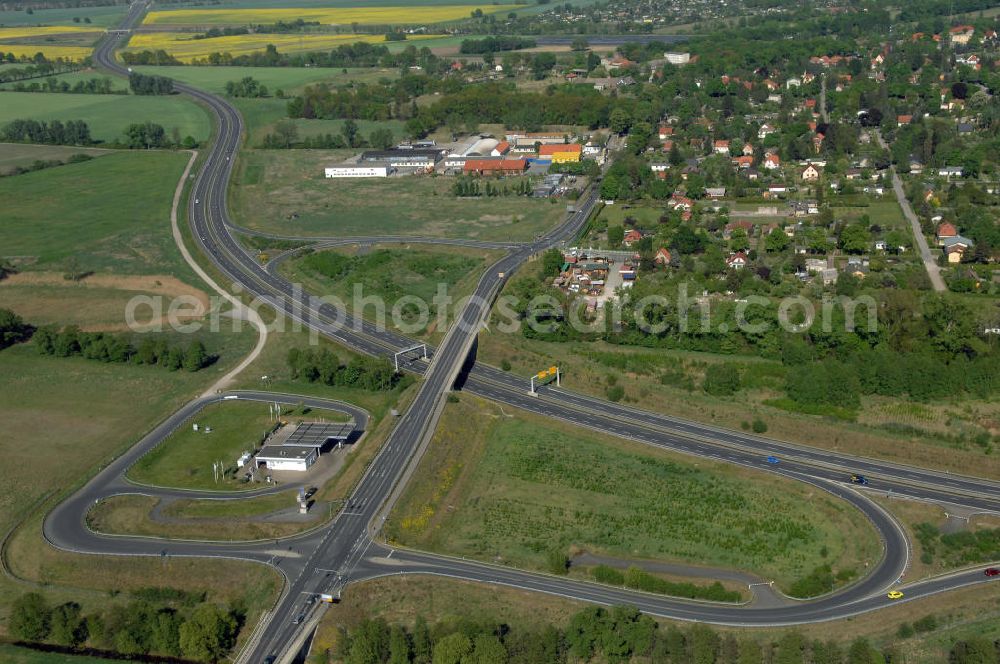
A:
[[32, 325, 218, 372]]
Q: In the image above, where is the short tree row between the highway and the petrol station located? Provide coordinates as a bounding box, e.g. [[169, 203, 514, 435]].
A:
[[287, 348, 403, 392]]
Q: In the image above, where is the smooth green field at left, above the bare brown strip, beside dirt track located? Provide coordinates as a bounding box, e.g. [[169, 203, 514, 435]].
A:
[[0, 150, 189, 274]]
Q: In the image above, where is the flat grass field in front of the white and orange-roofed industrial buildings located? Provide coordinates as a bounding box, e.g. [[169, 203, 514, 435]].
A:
[[230, 150, 566, 241]]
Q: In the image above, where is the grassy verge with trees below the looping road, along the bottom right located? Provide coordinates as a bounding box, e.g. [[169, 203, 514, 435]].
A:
[[314, 576, 1000, 664]]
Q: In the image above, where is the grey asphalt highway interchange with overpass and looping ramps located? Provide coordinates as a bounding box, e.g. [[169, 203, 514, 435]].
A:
[[50, 2, 1000, 662]]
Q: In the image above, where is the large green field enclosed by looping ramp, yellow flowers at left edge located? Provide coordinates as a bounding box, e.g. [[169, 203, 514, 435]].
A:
[[387, 396, 880, 588]]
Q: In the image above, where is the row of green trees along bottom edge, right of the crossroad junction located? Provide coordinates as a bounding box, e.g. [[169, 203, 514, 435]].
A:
[[326, 606, 944, 664]]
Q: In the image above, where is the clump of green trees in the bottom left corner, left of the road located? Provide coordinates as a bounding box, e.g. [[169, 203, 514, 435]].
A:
[[7, 588, 246, 663]]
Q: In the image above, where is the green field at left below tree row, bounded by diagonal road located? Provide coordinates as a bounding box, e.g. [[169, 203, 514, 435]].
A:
[[0, 330, 254, 544]]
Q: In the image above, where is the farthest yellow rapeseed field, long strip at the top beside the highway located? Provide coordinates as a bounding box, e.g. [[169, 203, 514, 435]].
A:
[[145, 4, 521, 25]]
